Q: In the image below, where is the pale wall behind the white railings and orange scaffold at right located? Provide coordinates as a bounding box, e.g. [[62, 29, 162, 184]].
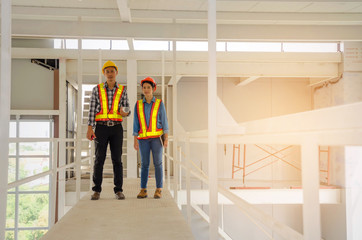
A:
[[178, 78, 312, 239]]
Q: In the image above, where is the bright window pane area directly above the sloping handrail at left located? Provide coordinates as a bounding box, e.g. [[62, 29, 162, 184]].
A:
[[19, 157, 49, 179]]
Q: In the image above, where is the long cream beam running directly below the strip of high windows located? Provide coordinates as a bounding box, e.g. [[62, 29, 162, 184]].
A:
[[11, 48, 342, 63]]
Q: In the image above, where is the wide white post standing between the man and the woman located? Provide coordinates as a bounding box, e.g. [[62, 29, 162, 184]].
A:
[[127, 59, 138, 178]]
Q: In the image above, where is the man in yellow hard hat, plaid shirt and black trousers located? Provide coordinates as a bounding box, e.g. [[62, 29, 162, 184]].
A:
[[87, 61, 131, 200]]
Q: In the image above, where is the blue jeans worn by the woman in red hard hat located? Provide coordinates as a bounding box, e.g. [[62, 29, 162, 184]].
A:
[[138, 138, 163, 188]]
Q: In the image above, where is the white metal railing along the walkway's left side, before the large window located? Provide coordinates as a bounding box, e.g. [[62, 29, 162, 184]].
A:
[[7, 138, 94, 228]]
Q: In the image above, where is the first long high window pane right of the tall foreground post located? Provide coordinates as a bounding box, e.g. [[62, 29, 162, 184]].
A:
[[227, 42, 282, 52]]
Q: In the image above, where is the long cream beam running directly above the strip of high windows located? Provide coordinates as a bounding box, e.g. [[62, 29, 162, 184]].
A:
[[12, 19, 362, 41]]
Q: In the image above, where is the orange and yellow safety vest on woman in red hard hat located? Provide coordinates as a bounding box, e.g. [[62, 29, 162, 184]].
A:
[[137, 99, 163, 139]]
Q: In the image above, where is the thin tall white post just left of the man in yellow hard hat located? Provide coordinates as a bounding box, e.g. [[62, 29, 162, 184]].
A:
[[75, 38, 83, 202]]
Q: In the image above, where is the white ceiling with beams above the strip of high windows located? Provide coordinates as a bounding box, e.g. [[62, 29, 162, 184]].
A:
[[3, 0, 362, 41]]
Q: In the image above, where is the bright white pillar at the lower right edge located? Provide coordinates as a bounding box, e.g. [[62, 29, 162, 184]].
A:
[[345, 146, 362, 240]]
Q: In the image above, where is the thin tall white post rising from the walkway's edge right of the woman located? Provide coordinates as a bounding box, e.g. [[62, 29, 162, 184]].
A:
[[172, 40, 178, 204]]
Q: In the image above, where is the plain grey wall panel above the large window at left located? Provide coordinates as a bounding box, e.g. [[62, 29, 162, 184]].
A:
[[11, 59, 54, 110]]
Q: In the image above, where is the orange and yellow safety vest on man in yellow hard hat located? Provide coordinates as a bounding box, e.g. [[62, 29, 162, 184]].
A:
[[95, 83, 124, 122]]
